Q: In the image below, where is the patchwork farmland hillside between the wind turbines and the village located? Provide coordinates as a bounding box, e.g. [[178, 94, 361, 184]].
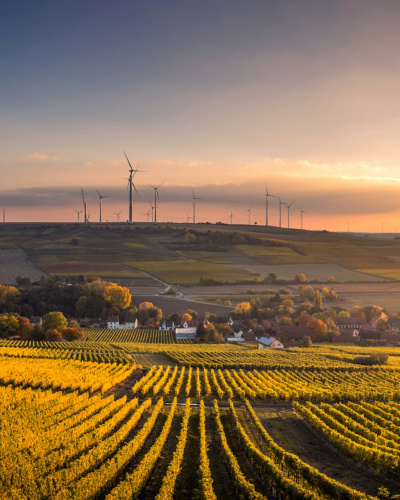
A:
[[0, 223, 400, 285]]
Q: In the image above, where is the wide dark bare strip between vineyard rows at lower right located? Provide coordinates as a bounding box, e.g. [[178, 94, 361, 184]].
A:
[[256, 407, 400, 495]]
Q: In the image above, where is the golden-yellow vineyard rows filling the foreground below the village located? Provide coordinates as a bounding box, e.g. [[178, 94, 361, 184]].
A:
[[0, 340, 400, 500]]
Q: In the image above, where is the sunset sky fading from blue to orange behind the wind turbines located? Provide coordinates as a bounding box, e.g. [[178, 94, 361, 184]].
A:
[[0, 0, 400, 232]]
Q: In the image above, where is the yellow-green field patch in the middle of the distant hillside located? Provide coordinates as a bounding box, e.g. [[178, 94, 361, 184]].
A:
[[128, 260, 260, 285]]
